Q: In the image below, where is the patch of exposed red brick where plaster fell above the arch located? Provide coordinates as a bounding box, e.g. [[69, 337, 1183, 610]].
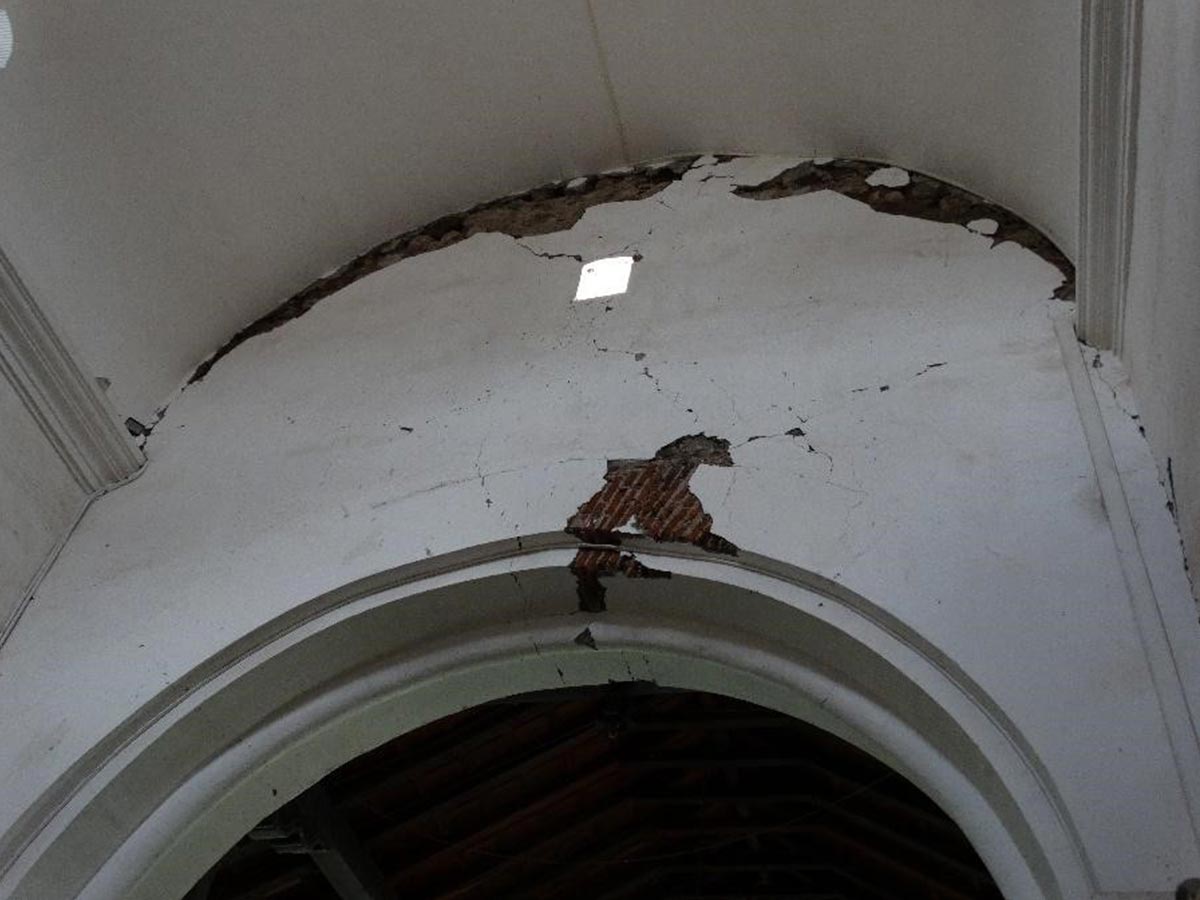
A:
[[566, 433, 738, 612]]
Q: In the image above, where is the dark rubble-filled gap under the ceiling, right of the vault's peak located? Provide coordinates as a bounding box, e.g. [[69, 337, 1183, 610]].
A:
[[733, 160, 1075, 300]]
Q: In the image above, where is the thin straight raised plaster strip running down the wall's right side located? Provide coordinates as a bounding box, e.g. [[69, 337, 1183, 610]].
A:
[[1052, 314, 1200, 839]]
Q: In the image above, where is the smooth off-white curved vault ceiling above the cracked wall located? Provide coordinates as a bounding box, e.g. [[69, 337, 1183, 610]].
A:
[[0, 0, 1079, 418]]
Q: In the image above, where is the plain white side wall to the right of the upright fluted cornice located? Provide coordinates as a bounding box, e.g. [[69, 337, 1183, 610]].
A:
[[1123, 0, 1200, 607]]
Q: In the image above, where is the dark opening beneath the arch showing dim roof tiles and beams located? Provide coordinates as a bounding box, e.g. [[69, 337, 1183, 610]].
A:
[[190, 682, 1000, 900]]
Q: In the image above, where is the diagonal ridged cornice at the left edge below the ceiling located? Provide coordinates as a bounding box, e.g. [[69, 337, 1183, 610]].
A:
[[0, 244, 143, 494]]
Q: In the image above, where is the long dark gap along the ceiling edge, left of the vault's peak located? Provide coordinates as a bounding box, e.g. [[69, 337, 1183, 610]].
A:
[[187, 156, 700, 384]]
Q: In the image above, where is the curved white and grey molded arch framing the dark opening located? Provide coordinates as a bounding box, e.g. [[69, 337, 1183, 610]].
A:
[[0, 534, 1094, 900]]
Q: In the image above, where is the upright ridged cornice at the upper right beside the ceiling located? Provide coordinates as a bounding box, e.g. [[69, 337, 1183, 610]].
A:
[[1078, 0, 1142, 352]]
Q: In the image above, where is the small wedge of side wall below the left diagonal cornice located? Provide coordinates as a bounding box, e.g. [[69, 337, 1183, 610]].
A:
[[0, 377, 85, 638]]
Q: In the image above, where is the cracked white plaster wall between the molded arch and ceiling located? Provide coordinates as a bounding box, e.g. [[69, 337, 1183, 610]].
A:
[[0, 160, 1200, 900]]
